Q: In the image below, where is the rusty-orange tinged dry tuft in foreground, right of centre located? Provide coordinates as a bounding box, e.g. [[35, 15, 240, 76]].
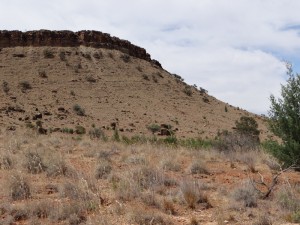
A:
[[180, 181, 208, 209]]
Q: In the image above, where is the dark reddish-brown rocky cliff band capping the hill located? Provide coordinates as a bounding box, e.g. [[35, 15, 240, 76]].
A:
[[0, 30, 161, 67]]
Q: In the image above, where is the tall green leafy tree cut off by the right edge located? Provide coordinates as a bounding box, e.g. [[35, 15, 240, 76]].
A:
[[269, 64, 300, 167]]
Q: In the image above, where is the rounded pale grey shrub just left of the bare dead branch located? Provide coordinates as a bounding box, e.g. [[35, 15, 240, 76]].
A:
[[232, 182, 258, 208]]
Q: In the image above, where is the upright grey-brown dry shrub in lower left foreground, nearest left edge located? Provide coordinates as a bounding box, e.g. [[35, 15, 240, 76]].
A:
[[9, 175, 31, 201]]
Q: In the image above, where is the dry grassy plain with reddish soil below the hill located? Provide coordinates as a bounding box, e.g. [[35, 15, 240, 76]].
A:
[[0, 133, 300, 225]]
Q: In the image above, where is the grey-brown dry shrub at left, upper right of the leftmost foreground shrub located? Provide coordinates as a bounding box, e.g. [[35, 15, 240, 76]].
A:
[[25, 152, 46, 174]]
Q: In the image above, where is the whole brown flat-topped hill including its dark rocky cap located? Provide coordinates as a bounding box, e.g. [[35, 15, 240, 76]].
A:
[[0, 30, 267, 138]]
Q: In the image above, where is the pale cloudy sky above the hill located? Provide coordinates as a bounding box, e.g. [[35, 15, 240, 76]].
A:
[[0, 0, 300, 114]]
